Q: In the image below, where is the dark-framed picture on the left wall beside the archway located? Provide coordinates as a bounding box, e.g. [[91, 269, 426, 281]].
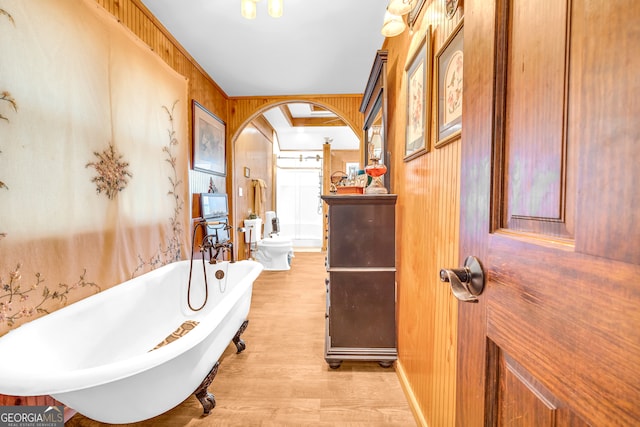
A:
[[193, 100, 227, 176]]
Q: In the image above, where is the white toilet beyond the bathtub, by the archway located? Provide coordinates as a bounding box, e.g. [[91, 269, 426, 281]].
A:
[[244, 211, 293, 271]]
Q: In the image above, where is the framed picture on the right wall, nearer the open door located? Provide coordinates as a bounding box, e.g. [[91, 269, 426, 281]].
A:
[[436, 21, 464, 147]]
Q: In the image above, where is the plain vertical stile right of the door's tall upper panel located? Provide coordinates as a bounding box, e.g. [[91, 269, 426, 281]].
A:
[[569, 0, 640, 265]]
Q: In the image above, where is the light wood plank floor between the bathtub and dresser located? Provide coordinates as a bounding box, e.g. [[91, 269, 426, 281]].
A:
[[65, 252, 416, 427]]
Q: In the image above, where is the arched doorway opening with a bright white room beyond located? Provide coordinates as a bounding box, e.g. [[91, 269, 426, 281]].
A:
[[232, 100, 361, 258]]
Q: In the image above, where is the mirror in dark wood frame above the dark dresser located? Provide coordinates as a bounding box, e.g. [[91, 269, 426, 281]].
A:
[[360, 50, 391, 193]]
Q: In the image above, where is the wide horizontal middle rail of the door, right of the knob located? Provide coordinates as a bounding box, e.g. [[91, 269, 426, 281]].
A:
[[485, 233, 640, 425]]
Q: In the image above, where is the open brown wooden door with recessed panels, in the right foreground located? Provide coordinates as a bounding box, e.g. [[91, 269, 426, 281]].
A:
[[456, 0, 640, 427]]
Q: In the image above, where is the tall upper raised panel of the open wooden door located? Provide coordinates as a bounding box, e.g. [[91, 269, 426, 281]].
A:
[[508, 0, 567, 227]]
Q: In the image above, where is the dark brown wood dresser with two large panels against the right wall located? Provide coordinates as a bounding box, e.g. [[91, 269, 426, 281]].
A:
[[322, 194, 398, 369]]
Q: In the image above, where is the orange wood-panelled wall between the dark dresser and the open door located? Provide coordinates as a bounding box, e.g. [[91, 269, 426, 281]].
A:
[[383, 1, 463, 426]]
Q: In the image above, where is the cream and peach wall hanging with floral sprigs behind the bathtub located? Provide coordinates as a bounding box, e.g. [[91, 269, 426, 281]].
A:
[[0, 0, 190, 335]]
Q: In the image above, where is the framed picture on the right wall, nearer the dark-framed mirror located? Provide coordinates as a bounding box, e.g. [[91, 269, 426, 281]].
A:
[[404, 27, 431, 162]]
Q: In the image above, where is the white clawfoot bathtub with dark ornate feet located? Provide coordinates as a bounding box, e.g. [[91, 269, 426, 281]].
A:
[[0, 260, 262, 424]]
